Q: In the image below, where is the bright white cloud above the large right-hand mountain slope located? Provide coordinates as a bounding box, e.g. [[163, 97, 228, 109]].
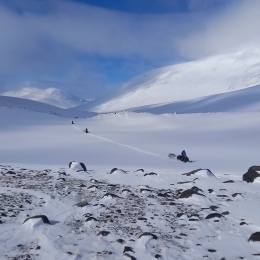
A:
[[179, 0, 260, 58]]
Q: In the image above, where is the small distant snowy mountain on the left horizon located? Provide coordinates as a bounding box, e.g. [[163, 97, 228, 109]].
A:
[[0, 87, 87, 108]]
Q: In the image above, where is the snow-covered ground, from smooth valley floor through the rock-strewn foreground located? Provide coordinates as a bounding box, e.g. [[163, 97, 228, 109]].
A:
[[0, 96, 260, 260]]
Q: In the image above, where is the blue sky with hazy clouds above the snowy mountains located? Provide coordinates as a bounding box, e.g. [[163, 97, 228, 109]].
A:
[[0, 0, 260, 98]]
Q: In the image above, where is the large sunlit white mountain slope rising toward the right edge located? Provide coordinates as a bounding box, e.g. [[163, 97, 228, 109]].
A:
[[78, 48, 260, 112]]
